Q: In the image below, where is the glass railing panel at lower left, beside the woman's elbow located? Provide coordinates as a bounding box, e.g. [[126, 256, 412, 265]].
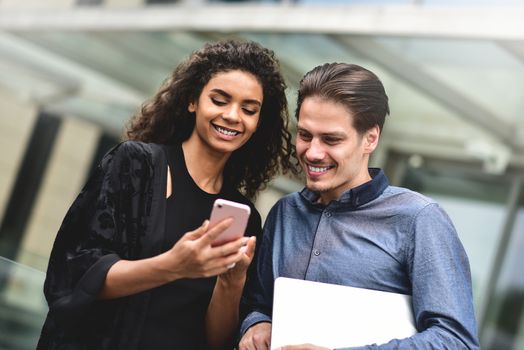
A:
[[0, 257, 47, 350]]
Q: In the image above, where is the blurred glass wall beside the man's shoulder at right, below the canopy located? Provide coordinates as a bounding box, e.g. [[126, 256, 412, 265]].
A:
[[386, 153, 524, 350]]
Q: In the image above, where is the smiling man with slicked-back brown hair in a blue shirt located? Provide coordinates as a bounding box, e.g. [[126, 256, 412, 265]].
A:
[[240, 63, 479, 350]]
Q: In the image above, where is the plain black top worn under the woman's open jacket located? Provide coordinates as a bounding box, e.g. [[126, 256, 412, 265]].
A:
[[140, 145, 260, 350]]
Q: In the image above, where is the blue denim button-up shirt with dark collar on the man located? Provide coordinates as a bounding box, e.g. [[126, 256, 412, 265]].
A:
[[241, 169, 479, 350]]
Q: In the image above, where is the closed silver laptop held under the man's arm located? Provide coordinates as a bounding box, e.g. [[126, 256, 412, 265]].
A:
[[271, 277, 417, 349]]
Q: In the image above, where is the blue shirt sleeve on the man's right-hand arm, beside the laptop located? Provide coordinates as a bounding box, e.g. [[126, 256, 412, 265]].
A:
[[340, 203, 480, 350]]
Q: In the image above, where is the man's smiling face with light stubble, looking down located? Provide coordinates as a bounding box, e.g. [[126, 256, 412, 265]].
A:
[[296, 96, 379, 204]]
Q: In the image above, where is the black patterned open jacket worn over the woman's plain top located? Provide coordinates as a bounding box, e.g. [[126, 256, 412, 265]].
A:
[[37, 141, 260, 350]]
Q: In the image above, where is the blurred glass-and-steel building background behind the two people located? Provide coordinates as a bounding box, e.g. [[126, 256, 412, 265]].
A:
[[0, 0, 524, 350]]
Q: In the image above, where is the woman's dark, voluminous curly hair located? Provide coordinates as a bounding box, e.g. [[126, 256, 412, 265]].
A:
[[127, 40, 296, 198]]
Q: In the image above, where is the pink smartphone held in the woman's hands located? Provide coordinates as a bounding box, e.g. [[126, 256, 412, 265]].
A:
[[209, 199, 251, 246]]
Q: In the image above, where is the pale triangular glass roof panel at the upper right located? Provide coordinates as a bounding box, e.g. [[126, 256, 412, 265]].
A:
[[377, 38, 524, 122]]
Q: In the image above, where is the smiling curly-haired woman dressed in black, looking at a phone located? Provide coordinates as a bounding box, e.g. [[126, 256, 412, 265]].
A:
[[38, 41, 292, 349]]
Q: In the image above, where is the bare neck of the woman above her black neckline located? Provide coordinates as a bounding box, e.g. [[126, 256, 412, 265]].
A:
[[182, 138, 229, 193]]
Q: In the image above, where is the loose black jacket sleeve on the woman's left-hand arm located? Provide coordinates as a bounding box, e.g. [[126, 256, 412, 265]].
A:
[[44, 143, 142, 328]]
